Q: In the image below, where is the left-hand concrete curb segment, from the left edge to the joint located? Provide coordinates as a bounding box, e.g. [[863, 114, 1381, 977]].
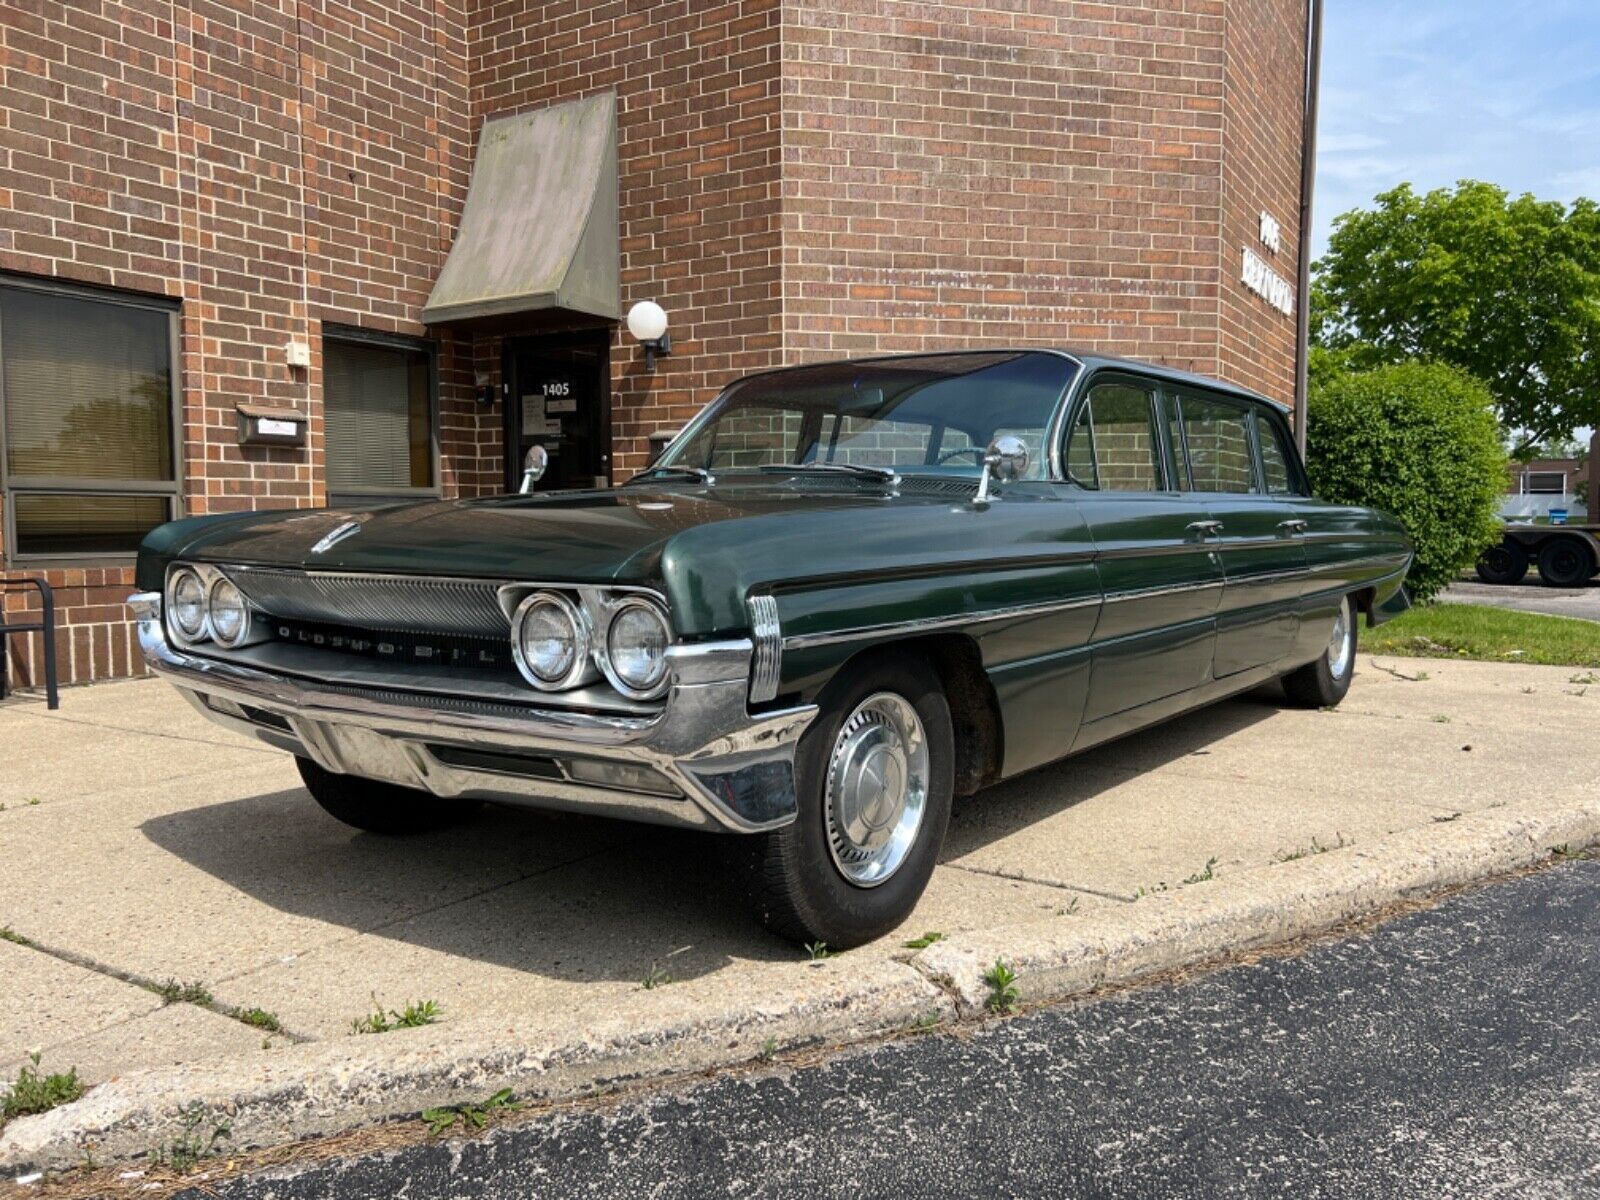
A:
[[0, 958, 955, 1174]]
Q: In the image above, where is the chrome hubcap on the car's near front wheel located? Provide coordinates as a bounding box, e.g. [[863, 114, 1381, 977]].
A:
[[826, 691, 928, 888]]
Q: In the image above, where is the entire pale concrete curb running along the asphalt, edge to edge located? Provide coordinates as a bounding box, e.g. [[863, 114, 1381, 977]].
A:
[[0, 800, 1600, 1173]]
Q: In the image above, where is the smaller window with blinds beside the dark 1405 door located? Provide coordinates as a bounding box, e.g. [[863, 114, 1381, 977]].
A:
[[322, 338, 434, 502]]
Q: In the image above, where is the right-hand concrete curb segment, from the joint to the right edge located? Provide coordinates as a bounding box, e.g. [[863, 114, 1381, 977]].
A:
[[912, 800, 1600, 1018]]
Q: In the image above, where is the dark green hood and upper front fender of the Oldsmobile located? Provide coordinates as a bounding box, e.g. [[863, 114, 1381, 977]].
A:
[[139, 477, 1085, 637]]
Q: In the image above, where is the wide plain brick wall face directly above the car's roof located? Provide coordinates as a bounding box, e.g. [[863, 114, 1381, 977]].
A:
[[784, 0, 1224, 371]]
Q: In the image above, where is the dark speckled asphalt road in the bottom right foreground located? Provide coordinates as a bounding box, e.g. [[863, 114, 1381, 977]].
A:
[[189, 862, 1600, 1200]]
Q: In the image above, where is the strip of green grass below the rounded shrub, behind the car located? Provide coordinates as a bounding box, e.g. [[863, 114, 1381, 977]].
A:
[[1362, 605, 1600, 667]]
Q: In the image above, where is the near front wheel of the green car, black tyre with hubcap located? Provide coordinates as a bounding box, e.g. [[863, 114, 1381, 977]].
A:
[[730, 658, 955, 950]]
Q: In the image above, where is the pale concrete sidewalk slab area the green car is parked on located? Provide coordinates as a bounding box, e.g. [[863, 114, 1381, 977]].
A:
[[0, 654, 1600, 1177]]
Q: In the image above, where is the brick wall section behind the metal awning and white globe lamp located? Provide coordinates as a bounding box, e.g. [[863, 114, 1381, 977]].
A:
[[472, 0, 782, 475]]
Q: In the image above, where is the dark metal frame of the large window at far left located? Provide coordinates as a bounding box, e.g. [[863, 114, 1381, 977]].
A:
[[0, 272, 184, 568]]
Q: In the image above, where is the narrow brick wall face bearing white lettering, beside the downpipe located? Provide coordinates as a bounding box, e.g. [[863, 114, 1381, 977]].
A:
[[1216, 0, 1306, 403]]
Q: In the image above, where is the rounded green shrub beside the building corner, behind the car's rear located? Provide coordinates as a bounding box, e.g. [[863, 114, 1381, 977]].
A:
[[1306, 363, 1506, 600]]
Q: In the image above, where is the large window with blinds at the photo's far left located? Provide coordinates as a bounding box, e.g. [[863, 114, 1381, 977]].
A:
[[0, 283, 178, 558]]
